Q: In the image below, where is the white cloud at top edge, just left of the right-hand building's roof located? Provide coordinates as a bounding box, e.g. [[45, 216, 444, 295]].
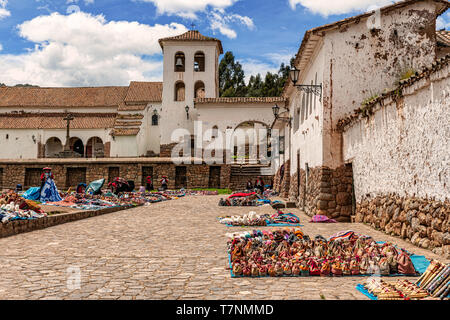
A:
[[289, 0, 400, 16]]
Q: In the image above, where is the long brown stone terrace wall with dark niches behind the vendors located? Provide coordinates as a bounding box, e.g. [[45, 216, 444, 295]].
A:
[[0, 159, 231, 190]]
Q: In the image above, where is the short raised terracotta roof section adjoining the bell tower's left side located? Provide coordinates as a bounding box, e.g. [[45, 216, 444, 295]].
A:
[[124, 81, 163, 104]]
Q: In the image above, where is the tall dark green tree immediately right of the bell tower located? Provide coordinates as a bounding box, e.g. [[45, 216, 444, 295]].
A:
[[219, 51, 247, 97]]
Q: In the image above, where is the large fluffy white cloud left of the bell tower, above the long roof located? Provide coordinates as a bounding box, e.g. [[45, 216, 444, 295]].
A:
[[0, 12, 187, 86]]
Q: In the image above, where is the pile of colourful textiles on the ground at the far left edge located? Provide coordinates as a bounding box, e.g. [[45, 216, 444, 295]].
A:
[[0, 191, 47, 223]]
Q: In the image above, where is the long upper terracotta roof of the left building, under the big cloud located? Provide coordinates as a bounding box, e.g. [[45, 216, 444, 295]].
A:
[[0, 87, 128, 108]]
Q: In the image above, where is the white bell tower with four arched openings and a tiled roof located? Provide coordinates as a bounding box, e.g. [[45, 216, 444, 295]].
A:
[[159, 30, 223, 157]]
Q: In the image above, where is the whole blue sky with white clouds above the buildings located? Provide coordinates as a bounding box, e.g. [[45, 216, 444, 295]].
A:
[[0, 0, 450, 87]]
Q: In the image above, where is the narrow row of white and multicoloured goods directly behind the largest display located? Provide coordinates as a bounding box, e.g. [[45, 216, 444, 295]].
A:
[[219, 211, 300, 227]]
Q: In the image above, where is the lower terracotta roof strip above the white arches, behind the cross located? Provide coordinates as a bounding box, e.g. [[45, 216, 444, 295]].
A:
[[0, 113, 116, 129]]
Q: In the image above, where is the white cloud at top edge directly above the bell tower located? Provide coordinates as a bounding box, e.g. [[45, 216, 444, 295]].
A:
[[140, 0, 238, 19]]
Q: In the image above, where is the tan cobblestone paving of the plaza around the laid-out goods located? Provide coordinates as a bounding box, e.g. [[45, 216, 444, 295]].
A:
[[0, 196, 445, 300]]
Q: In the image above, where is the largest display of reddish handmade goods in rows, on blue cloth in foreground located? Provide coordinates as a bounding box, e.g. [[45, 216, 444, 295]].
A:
[[228, 228, 424, 277]]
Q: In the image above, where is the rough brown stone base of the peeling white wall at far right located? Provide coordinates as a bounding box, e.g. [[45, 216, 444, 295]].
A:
[[355, 194, 450, 258]]
